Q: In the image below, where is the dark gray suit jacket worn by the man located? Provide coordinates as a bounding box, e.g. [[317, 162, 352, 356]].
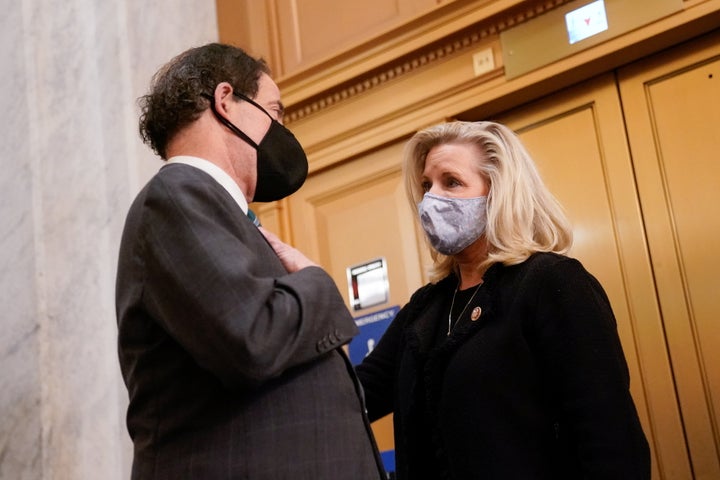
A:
[[116, 164, 384, 480]]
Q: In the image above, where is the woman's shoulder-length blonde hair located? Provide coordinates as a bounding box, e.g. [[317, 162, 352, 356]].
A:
[[403, 122, 572, 281]]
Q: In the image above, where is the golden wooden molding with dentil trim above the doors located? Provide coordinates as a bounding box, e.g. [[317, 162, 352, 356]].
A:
[[278, 0, 720, 174]]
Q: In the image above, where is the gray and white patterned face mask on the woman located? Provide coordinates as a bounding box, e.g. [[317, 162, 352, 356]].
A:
[[418, 193, 487, 255]]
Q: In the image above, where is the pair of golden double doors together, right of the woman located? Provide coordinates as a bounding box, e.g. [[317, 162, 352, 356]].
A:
[[492, 32, 720, 480]]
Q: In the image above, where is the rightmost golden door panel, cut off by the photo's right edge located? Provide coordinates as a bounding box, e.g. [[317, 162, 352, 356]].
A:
[[619, 32, 720, 480]]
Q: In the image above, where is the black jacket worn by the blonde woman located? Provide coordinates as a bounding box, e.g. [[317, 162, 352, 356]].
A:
[[357, 253, 650, 480]]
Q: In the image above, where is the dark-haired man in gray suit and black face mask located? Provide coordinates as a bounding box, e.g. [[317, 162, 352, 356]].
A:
[[116, 44, 384, 480]]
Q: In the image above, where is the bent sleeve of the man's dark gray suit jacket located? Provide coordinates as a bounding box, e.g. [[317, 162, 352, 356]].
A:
[[134, 168, 357, 388]]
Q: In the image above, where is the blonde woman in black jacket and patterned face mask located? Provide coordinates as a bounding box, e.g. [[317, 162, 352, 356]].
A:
[[357, 122, 650, 480]]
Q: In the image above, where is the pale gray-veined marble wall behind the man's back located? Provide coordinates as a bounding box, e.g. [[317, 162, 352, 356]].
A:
[[0, 0, 217, 480]]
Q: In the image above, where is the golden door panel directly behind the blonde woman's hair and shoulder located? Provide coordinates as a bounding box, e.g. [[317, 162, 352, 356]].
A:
[[499, 74, 691, 478]]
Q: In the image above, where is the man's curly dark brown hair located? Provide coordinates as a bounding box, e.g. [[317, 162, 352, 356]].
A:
[[138, 43, 270, 160]]
